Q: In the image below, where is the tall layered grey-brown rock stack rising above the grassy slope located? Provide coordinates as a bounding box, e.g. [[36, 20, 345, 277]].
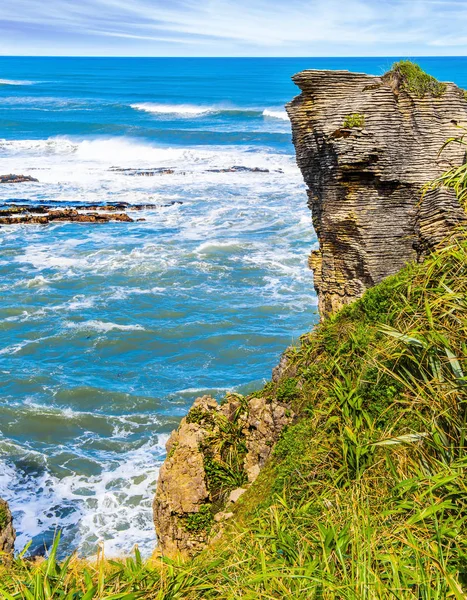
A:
[[287, 70, 467, 316]]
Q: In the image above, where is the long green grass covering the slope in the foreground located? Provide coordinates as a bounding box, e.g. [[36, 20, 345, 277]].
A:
[[0, 233, 467, 600]]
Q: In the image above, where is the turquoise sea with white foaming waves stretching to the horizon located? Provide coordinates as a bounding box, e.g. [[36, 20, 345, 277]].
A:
[[0, 58, 467, 555]]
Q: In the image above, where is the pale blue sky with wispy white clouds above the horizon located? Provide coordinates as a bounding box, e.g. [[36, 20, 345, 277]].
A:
[[0, 0, 467, 56]]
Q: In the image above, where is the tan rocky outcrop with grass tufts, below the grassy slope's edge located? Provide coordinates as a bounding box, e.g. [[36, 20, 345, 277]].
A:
[[154, 395, 293, 556]]
